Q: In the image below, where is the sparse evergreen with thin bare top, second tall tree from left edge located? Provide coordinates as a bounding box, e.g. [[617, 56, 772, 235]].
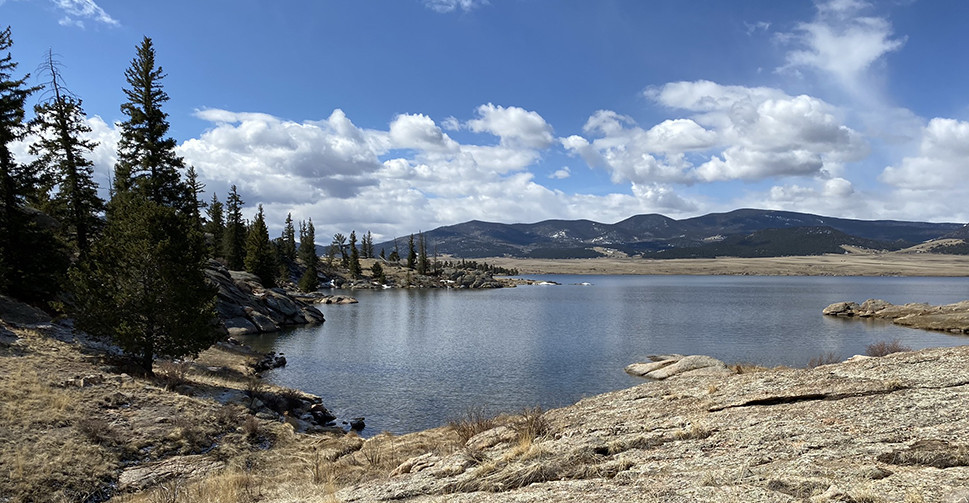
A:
[[30, 52, 104, 255]]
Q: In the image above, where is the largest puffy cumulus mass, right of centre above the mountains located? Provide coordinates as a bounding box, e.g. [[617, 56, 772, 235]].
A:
[[560, 80, 868, 189]]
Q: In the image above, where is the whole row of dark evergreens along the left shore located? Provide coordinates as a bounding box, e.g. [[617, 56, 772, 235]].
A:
[[0, 27, 516, 373]]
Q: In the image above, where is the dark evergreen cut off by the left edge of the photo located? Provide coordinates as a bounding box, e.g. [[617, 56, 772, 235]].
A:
[[0, 27, 67, 301]]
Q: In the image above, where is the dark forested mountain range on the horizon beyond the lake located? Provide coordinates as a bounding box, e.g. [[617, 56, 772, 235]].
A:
[[375, 209, 965, 258]]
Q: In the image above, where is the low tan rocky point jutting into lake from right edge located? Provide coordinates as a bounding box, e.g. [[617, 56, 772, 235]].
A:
[[821, 299, 969, 334]]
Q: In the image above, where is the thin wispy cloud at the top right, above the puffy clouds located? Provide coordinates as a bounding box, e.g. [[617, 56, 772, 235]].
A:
[[780, 0, 905, 92]]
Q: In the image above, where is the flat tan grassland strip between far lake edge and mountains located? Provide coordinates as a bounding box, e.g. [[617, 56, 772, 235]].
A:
[[483, 253, 969, 276]]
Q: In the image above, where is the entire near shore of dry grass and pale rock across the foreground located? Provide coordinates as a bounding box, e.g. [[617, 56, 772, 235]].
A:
[[0, 292, 969, 503]]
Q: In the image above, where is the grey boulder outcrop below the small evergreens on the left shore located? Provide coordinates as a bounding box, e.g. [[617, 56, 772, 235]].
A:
[[205, 261, 324, 335]]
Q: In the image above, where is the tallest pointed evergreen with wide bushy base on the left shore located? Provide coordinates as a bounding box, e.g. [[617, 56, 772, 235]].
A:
[[71, 37, 219, 374]]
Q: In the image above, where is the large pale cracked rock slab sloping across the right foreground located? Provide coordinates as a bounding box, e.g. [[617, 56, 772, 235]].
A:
[[332, 347, 969, 503]]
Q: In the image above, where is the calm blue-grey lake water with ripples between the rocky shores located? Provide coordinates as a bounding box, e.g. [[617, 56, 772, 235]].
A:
[[247, 276, 969, 434]]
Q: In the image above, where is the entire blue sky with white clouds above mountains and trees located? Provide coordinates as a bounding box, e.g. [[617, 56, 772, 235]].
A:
[[0, 0, 969, 242]]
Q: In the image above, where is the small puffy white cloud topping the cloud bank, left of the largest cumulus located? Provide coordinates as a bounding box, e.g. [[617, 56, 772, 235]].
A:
[[466, 103, 555, 149]]
